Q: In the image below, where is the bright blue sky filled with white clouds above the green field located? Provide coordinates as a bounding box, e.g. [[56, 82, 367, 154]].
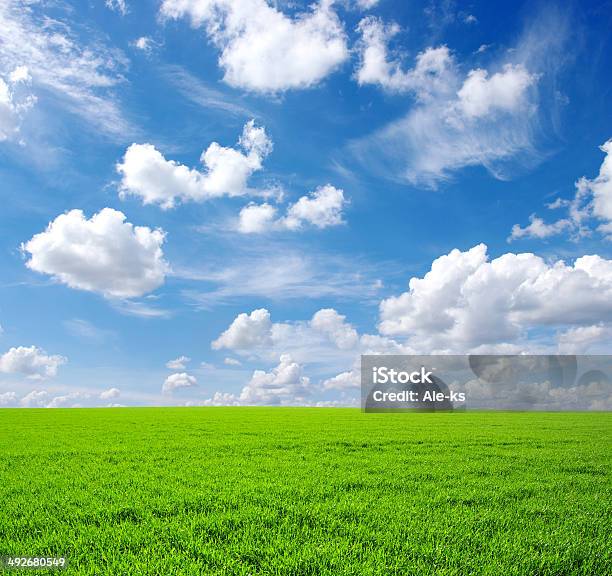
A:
[[0, 0, 612, 407]]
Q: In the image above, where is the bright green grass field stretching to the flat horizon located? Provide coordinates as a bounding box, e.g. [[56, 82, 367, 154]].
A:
[[0, 408, 612, 576]]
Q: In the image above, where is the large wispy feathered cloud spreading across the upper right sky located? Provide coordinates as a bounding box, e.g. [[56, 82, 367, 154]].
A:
[[349, 10, 568, 187]]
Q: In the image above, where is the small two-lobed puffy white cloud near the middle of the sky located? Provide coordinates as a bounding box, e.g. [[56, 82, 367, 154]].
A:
[[238, 184, 347, 234]]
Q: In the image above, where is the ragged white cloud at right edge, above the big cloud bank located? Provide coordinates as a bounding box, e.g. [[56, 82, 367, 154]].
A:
[[508, 140, 612, 241]]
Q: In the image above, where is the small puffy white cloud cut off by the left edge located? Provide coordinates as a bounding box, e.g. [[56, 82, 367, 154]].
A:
[[0, 66, 36, 142]]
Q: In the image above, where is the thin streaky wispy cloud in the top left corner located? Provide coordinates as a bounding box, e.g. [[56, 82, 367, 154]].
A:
[[0, 0, 134, 138]]
